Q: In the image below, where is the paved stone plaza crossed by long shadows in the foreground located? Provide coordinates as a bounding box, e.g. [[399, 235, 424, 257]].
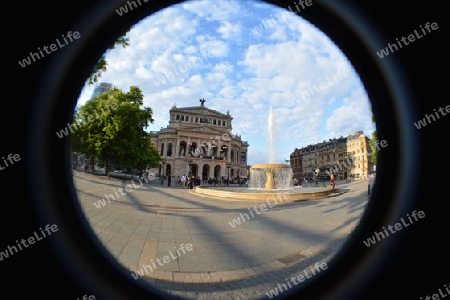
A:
[[73, 171, 368, 299]]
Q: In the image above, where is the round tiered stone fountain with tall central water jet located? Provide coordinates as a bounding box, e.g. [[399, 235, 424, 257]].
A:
[[192, 107, 339, 202]]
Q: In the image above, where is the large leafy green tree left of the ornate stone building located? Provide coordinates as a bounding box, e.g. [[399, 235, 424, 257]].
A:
[[71, 86, 161, 178]]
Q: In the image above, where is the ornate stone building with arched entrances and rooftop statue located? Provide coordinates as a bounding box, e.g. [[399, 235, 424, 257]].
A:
[[151, 99, 249, 180]]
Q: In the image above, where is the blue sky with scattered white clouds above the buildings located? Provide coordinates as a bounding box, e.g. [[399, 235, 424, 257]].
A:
[[78, 0, 375, 165]]
